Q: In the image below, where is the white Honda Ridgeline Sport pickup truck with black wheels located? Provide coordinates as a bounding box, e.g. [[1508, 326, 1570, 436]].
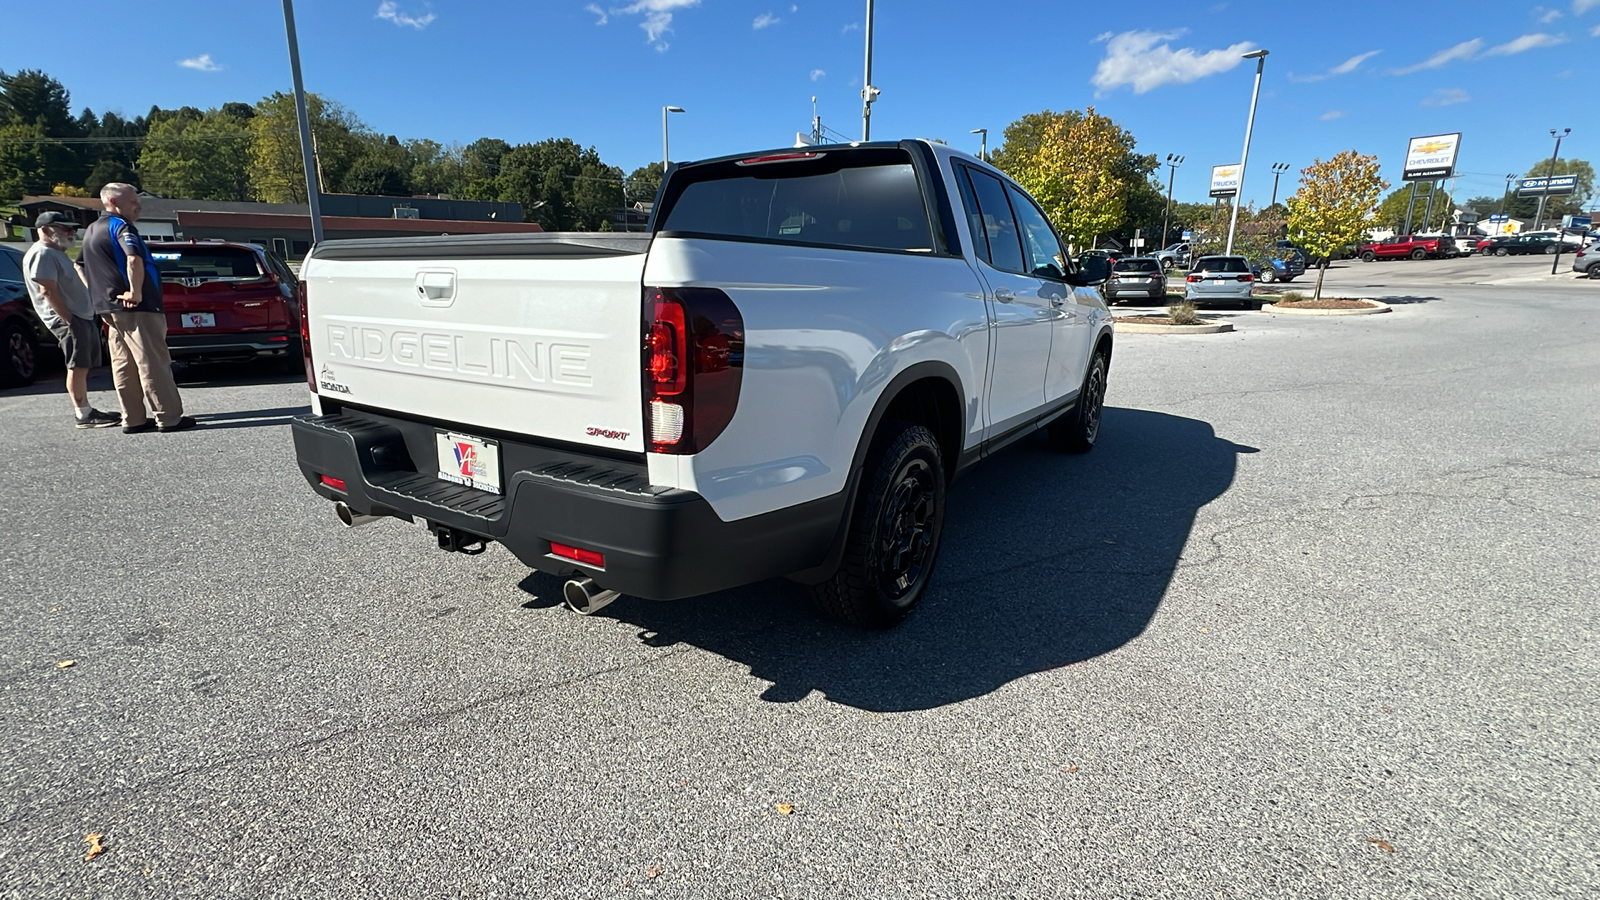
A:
[[293, 141, 1112, 628]]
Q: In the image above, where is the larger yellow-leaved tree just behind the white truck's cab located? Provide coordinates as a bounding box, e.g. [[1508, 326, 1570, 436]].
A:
[[995, 106, 1131, 247]]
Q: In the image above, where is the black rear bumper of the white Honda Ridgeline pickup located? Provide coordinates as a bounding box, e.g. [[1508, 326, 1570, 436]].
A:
[[293, 410, 846, 601]]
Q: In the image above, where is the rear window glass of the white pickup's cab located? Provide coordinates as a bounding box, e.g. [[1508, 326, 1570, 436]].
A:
[[659, 149, 933, 253]]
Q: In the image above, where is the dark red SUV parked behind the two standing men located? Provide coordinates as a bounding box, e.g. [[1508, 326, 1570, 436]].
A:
[[149, 240, 304, 364]]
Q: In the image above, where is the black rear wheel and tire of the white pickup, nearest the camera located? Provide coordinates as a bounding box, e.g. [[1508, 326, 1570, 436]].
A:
[[811, 421, 946, 629]]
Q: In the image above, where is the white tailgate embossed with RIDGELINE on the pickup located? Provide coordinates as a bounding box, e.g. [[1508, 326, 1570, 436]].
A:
[[301, 234, 650, 452]]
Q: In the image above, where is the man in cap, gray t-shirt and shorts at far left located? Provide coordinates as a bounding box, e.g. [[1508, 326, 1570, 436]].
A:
[[22, 213, 122, 428]]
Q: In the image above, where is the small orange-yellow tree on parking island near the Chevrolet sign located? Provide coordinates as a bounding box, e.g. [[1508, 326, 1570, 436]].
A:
[[1288, 151, 1389, 299]]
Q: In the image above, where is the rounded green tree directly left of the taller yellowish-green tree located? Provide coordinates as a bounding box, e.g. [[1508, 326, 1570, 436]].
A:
[[137, 109, 251, 200]]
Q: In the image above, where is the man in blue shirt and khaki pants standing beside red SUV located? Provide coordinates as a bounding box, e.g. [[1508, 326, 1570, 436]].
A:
[[78, 181, 195, 434]]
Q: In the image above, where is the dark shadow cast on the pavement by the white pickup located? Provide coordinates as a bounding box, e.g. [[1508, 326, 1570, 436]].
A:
[[523, 408, 1256, 713]]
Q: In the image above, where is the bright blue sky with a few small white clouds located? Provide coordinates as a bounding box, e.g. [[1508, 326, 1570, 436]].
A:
[[0, 0, 1600, 202]]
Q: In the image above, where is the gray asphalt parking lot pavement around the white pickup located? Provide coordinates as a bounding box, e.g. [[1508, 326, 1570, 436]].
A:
[[0, 258, 1600, 898]]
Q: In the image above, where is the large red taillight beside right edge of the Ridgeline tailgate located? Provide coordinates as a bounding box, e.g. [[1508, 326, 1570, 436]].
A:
[[643, 288, 744, 453]]
